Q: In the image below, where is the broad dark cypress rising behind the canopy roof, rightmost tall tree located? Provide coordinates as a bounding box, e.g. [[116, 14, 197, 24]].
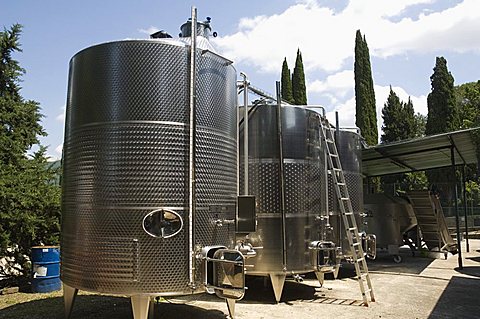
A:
[[425, 57, 460, 135]]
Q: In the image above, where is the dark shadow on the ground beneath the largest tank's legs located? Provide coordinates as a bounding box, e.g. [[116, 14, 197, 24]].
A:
[[0, 295, 226, 319]]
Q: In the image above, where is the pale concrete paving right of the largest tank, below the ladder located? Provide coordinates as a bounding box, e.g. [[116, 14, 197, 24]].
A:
[[164, 240, 480, 319]]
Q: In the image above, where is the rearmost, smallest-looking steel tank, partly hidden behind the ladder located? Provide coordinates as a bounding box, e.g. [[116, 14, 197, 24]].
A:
[[328, 129, 364, 258]]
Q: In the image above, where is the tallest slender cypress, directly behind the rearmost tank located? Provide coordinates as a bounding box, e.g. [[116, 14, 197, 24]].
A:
[[354, 30, 378, 145]]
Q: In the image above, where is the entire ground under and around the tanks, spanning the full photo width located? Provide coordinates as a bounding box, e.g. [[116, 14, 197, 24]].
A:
[[0, 240, 480, 319]]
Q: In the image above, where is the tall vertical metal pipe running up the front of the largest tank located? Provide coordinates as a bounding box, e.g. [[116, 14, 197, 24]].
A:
[[188, 6, 197, 289]]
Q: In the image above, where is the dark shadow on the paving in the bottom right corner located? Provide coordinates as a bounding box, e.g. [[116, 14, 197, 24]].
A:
[[428, 276, 480, 319]]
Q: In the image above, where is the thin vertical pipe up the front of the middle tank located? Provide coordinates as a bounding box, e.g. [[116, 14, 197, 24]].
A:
[[276, 81, 287, 271]]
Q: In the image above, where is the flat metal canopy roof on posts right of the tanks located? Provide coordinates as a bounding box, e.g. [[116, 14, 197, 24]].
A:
[[362, 128, 480, 176]]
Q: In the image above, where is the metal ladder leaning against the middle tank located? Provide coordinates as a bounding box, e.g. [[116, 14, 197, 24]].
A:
[[320, 118, 375, 307]]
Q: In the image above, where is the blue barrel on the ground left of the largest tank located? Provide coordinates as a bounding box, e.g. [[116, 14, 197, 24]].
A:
[[31, 246, 62, 292]]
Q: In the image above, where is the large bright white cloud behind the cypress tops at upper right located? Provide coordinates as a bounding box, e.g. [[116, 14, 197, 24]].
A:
[[214, 0, 480, 73]]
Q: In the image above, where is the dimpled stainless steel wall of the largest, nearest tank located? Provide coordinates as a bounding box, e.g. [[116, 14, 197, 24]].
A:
[[61, 39, 237, 295]]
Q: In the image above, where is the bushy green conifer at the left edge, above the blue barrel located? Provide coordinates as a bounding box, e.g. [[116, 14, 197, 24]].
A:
[[0, 24, 60, 277]]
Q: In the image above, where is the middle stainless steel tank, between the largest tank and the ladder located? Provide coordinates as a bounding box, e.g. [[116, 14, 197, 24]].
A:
[[237, 104, 326, 300]]
